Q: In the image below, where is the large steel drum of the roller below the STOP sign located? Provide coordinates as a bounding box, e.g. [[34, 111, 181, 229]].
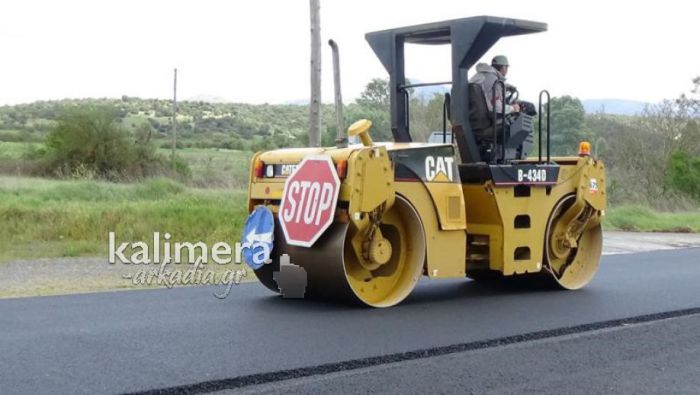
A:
[[255, 196, 425, 307]]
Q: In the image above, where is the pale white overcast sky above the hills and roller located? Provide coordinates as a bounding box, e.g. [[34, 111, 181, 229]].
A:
[[0, 0, 700, 104]]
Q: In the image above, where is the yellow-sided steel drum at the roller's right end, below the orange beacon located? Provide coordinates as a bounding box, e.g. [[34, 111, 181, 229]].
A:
[[545, 195, 603, 289]]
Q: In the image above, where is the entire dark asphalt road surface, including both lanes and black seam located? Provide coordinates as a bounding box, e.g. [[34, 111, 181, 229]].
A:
[[0, 248, 700, 394]]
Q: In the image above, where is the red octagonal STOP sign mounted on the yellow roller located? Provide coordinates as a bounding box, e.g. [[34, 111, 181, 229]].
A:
[[278, 155, 340, 247]]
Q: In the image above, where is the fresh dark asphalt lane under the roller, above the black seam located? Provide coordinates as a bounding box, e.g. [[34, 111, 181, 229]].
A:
[[0, 249, 700, 394]]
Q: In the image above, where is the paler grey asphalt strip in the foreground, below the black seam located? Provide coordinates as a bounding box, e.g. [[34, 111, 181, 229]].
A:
[[239, 315, 700, 395]]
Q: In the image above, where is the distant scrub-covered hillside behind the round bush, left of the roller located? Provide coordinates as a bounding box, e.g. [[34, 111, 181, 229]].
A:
[[0, 95, 335, 149]]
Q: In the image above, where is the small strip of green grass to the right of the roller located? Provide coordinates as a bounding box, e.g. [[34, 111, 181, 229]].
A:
[[604, 205, 700, 232]]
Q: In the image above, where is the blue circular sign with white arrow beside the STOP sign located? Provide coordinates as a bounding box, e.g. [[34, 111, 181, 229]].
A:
[[241, 206, 275, 270]]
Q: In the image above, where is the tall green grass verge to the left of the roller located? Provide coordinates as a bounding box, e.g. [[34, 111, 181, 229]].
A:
[[0, 176, 247, 262]]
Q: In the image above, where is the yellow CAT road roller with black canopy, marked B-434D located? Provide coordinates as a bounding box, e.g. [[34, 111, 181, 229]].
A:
[[244, 16, 606, 307]]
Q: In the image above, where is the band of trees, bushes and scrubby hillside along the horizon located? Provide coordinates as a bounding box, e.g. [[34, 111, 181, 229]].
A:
[[0, 77, 700, 208]]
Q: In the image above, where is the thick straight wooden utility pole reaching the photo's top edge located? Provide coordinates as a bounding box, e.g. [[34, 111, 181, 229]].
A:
[[309, 0, 321, 147]]
